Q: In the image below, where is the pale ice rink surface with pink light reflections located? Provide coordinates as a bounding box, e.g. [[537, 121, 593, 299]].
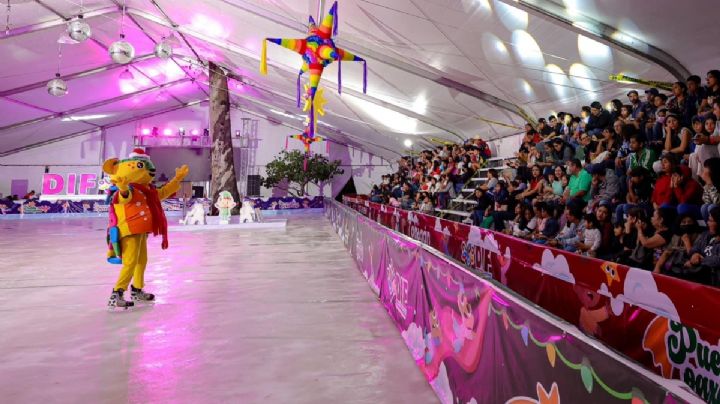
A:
[[0, 214, 437, 403]]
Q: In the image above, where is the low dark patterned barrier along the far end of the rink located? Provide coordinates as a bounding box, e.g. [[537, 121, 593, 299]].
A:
[[0, 196, 323, 215]]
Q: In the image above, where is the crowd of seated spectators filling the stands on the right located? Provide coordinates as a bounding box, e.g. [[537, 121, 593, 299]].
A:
[[370, 70, 720, 286]]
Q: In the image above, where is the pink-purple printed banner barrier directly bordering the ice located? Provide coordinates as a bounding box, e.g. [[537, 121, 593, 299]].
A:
[[325, 200, 702, 404]]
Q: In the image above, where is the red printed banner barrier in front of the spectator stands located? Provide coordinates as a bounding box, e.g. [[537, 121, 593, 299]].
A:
[[344, 197, 720, 403]]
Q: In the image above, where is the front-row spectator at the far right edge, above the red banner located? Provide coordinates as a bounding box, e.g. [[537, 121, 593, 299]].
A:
[[684, 206, 720, 286]]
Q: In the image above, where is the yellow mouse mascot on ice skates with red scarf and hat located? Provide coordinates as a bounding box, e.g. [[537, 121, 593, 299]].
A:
[[103, 149, 190, 309]]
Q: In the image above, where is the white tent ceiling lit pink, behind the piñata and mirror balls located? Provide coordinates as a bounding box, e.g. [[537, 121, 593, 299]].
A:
[[0, 0, 718, 157]]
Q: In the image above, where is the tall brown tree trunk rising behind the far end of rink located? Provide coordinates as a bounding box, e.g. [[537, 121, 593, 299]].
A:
[[208, 62, 240, 215]]
